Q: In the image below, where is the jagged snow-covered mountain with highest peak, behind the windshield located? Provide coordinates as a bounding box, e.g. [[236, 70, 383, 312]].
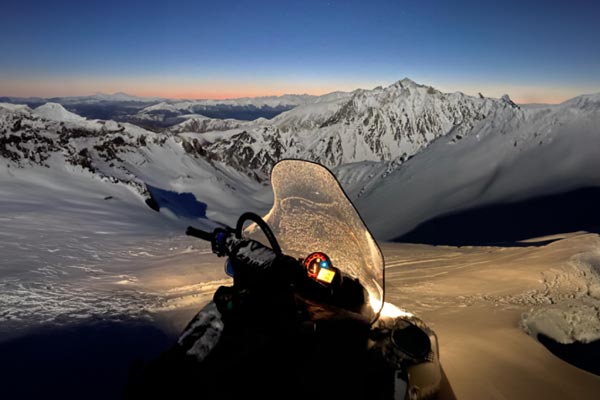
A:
[[185, 79, 504, 179]]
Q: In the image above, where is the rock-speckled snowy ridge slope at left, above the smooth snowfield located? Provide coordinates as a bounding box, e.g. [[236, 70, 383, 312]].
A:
[[0, 104, 269, 223]]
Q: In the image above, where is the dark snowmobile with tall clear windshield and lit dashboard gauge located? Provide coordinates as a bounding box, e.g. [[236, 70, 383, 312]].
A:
[[126, 160, 443, 399]]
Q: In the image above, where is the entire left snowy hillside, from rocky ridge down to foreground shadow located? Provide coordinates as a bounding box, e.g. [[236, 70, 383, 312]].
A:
[[0, 104, 272, 332]]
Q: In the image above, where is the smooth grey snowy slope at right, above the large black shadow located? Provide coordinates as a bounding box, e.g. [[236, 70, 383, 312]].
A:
[[357, 95, 600, 239]]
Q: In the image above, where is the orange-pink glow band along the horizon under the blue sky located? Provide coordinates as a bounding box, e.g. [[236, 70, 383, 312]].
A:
[[0, 76, 600, 104]]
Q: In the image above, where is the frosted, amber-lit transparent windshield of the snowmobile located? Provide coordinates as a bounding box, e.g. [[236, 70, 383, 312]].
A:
[[249, 160, 384, 322]]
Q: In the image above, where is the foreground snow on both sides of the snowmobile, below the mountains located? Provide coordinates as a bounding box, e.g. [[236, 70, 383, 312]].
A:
[[0, 161, 600, 399]]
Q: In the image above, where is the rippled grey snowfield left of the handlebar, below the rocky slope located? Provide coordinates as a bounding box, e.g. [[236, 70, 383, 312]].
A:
[[0, 164, 220, 339]]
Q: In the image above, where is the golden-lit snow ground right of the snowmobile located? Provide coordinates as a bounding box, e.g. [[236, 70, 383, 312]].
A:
[[382, 233, 600, 399]]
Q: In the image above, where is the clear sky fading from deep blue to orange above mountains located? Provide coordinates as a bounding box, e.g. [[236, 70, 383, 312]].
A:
[[0, 0, 600, 103]]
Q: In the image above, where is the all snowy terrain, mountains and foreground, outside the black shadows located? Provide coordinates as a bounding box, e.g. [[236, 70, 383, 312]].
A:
[[0, 80, 600, 399]]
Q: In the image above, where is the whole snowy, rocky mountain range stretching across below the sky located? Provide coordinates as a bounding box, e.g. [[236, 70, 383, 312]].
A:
[[0, 79, 600, 239]]
